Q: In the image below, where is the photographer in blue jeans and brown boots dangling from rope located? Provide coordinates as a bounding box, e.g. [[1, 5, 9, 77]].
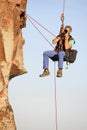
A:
[[39, 25, 75, 77]]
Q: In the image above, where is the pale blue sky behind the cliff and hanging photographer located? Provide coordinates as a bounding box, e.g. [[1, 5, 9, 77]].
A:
[[9, 0, 87, 130]]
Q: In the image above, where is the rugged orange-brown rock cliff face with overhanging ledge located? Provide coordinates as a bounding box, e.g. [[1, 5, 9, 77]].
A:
[[0, 0, 27, 130]]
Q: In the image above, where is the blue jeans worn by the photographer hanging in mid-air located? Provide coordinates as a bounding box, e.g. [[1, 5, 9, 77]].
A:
[[43, 50, 65, 69]]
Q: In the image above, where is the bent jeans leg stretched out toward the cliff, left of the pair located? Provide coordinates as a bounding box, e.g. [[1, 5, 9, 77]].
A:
[[43, 50, 57, 69]]
